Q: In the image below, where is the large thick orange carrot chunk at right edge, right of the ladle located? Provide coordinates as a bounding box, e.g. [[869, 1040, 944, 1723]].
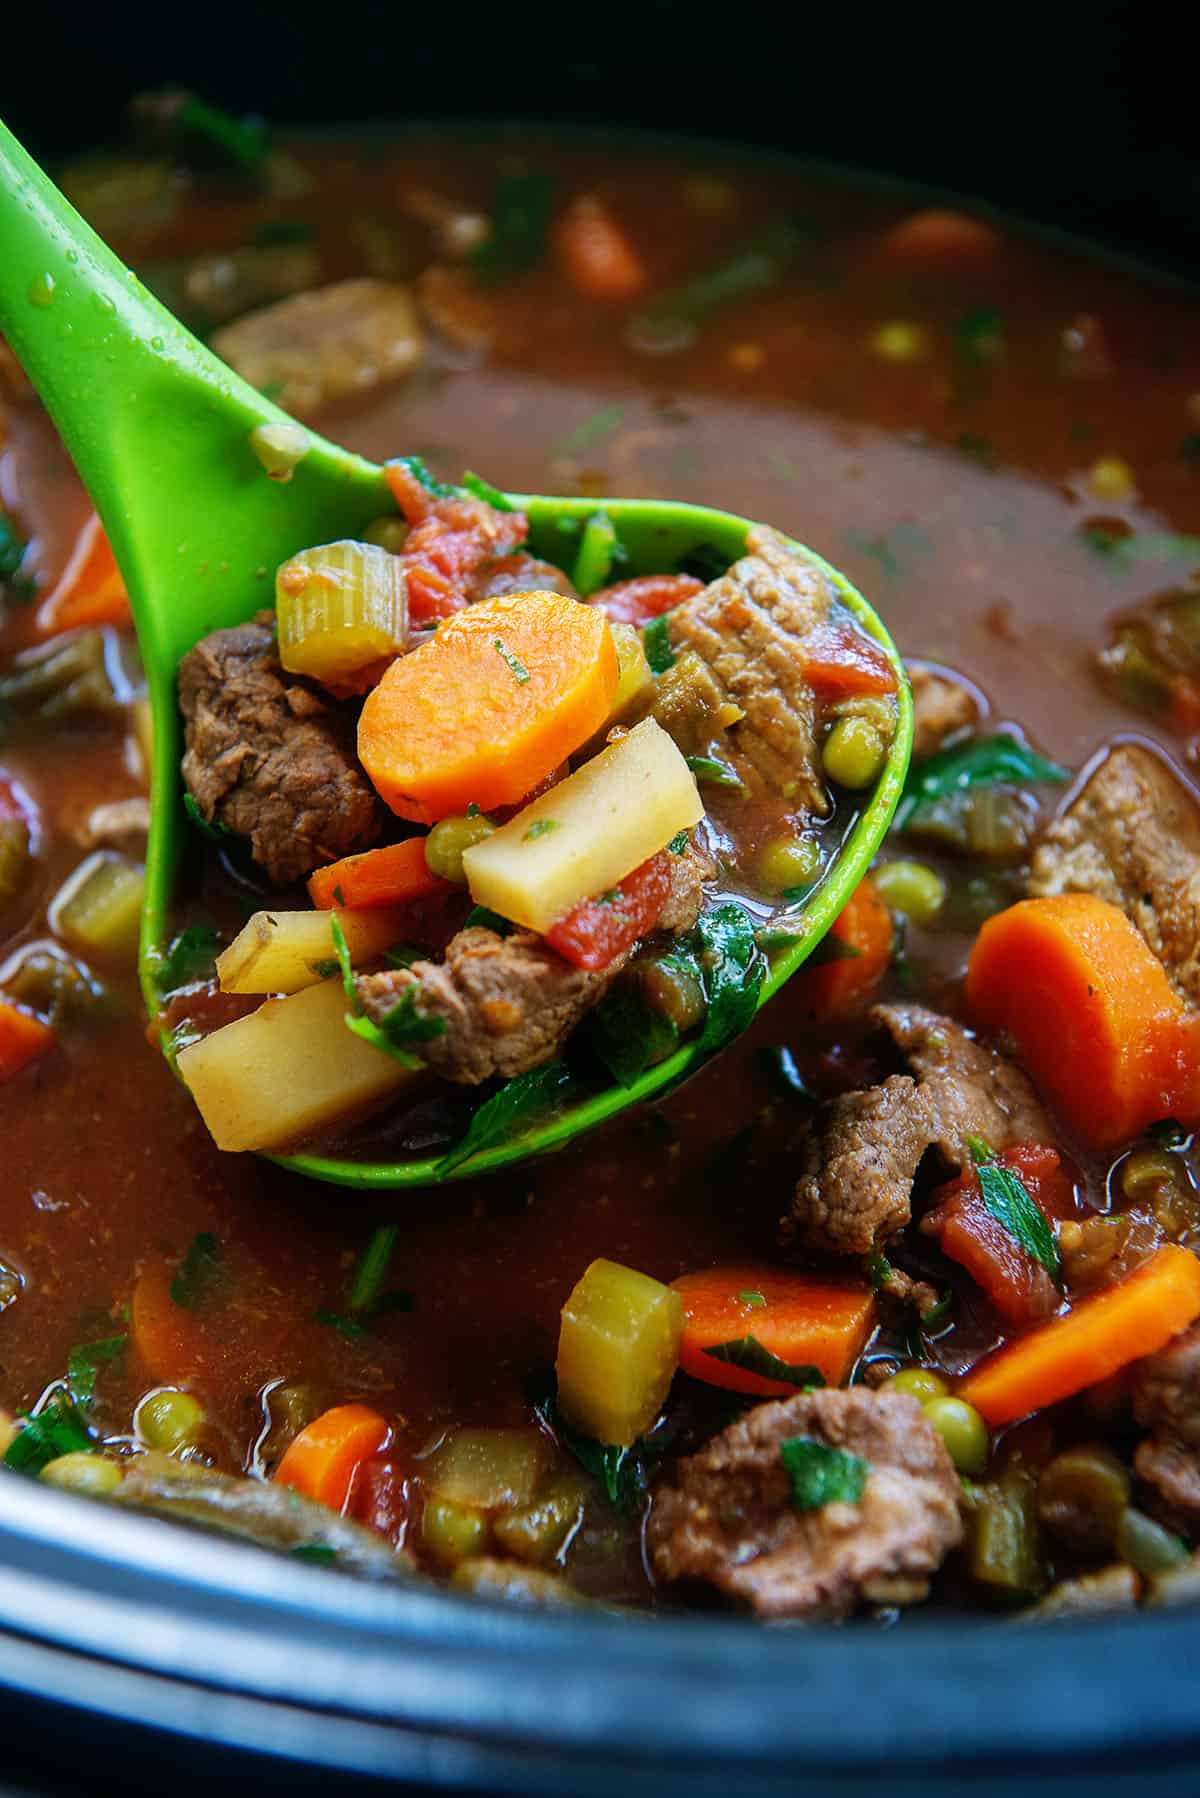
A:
[[966, 894, 1200, 1147]]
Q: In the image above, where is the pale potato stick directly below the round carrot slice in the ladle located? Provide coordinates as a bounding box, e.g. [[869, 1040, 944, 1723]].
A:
[[462, 717, 703, 933]]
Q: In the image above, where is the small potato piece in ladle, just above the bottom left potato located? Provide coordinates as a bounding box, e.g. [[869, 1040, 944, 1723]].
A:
[[216, 906, 405, 992]]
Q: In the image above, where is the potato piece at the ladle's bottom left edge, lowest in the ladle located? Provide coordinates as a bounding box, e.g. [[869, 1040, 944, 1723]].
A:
[[178, 980, 421, 1151]]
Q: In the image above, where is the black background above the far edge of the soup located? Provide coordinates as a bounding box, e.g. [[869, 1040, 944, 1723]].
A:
[[0, 0, 1200, 271]]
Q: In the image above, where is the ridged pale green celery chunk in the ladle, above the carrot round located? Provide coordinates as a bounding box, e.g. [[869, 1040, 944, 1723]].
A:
[[275, 541, 408, 685]]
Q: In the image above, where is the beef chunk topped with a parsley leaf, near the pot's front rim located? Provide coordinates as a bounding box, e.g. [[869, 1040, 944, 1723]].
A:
[[646, 1386, 963, 1620]]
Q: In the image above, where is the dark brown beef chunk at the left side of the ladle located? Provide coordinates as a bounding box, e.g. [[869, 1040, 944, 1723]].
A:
[[180, 613, 383, 886]]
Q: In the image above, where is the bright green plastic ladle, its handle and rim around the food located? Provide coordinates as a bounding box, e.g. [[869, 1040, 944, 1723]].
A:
[[0, 124, 912, 1187]]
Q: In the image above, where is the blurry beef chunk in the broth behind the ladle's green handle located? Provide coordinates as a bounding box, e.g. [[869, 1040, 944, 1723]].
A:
[[212, 277, 421, 417]]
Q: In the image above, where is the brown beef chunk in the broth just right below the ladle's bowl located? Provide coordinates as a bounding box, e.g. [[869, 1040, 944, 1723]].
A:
[[781, 1005, 1051, 1255]]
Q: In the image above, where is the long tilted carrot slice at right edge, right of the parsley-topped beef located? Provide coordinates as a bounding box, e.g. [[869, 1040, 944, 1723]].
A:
[[959, 1242, 1200, 1428]]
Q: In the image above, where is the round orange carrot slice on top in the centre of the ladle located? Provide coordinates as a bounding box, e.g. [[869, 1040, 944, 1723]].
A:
[[358, 592, 619, 823]]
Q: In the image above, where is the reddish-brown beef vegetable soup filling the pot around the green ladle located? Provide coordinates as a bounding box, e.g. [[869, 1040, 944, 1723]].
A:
[[0, 119, 1200, 1618]]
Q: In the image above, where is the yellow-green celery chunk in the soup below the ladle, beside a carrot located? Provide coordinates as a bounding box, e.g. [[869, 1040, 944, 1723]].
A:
[[556, 1260, 684, 1447]]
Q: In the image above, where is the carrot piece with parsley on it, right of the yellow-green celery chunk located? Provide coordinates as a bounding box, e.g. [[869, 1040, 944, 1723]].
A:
[[671, 1262, 874, 1399]]
